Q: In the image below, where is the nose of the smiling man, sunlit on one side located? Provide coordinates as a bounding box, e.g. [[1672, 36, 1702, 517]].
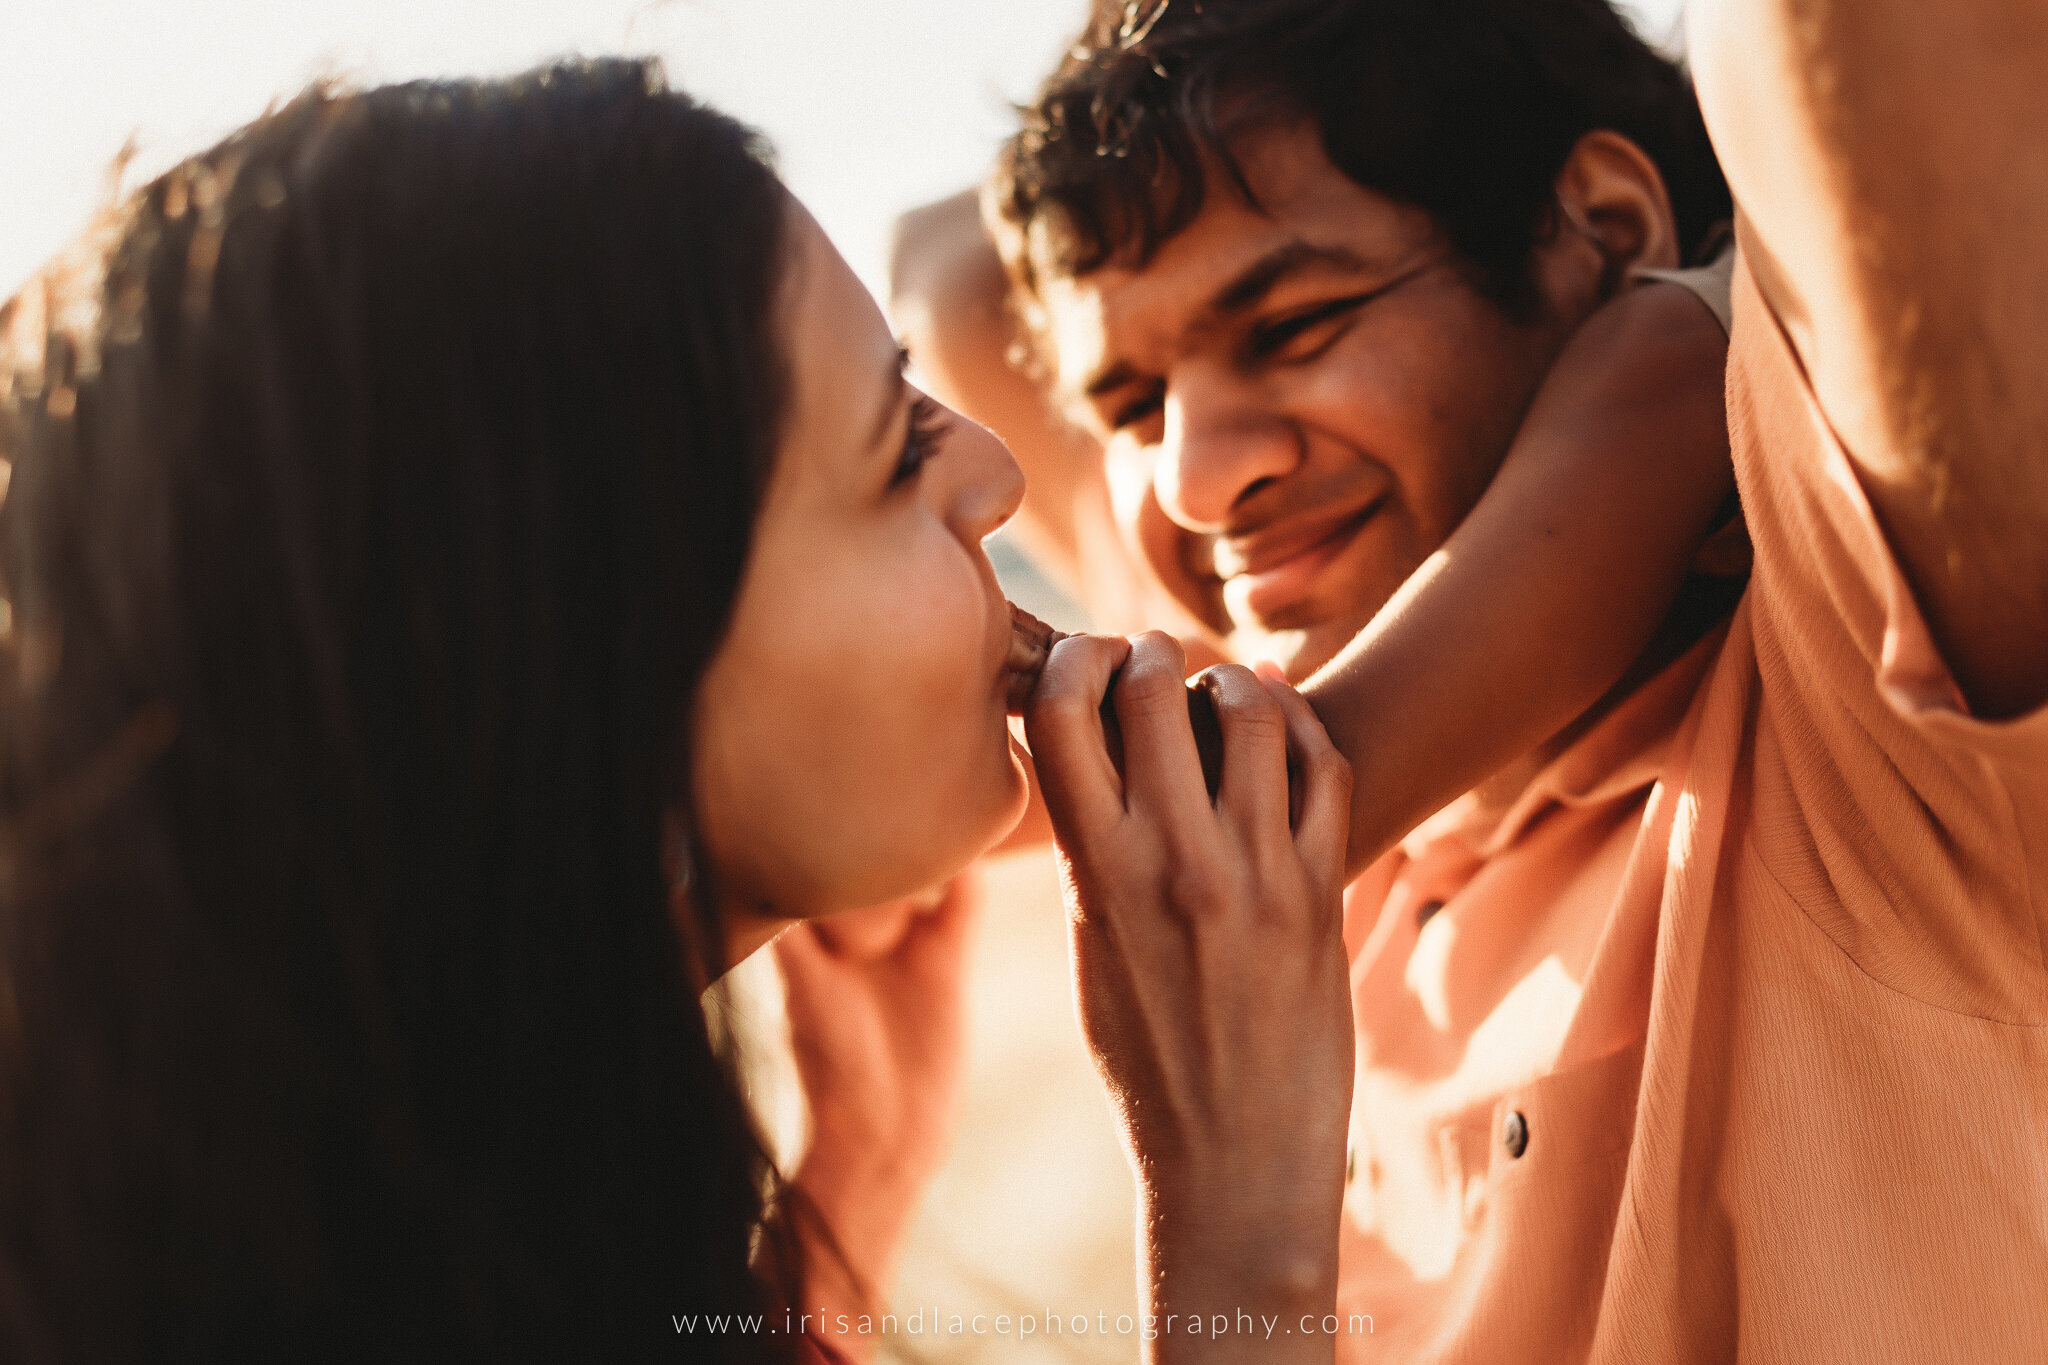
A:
[[1153, 366, 1300, 532]]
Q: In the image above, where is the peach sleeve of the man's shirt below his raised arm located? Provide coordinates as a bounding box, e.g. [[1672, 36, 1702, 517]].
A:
[[1729, 245, 2048, 1023]]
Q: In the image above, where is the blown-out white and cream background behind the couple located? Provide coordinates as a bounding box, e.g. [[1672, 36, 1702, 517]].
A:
[[0, 0, 1679, 1363]]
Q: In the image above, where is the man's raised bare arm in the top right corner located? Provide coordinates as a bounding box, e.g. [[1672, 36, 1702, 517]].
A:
[[1690, 0, 2048, 714]]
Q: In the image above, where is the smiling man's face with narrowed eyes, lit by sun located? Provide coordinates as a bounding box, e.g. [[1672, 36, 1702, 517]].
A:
[[1047, 125, 1593, 681]]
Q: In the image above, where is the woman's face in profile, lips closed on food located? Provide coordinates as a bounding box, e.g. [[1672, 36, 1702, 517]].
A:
[[694, 201, 1026, 960]]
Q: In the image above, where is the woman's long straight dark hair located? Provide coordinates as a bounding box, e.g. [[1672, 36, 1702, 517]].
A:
[[0, 61, 793, 1363]]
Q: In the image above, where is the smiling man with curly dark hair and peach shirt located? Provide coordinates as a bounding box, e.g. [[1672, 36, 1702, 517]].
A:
[[897, 0, 2048, 1361]]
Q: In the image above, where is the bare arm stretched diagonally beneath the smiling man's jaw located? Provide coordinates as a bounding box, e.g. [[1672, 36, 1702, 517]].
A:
[[1303, 272, 1733, 876]]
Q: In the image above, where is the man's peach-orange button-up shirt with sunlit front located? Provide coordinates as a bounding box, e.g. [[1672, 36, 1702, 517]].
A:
[[1337, 250, 2048, 1365]]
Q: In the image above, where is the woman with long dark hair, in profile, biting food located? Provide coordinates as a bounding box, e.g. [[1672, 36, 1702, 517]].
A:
[[0, 50, 1341, 1363]]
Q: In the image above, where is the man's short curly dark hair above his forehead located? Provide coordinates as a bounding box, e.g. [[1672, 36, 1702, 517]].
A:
[[989, 0, 1731, 313]]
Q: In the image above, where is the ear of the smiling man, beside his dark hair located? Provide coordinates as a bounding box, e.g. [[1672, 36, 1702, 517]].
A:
[[1536, 129, 1679, 299]]
